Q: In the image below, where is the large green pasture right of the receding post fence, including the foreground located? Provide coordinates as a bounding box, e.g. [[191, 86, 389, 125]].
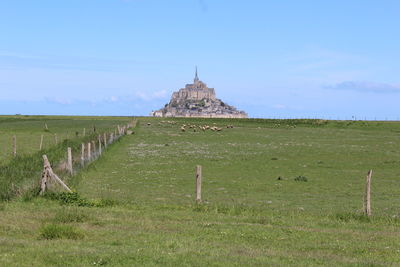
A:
[[0, 117, 400, 266]]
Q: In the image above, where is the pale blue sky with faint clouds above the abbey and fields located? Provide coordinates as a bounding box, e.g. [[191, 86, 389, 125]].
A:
[[0, 0, 400, 120]]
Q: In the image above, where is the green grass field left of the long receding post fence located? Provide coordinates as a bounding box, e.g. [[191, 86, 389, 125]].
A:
[[0, 116, 132, 201]]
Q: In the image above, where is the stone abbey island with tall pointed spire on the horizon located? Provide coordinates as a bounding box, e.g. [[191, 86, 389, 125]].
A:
[[151, 68, 247, 118]]
